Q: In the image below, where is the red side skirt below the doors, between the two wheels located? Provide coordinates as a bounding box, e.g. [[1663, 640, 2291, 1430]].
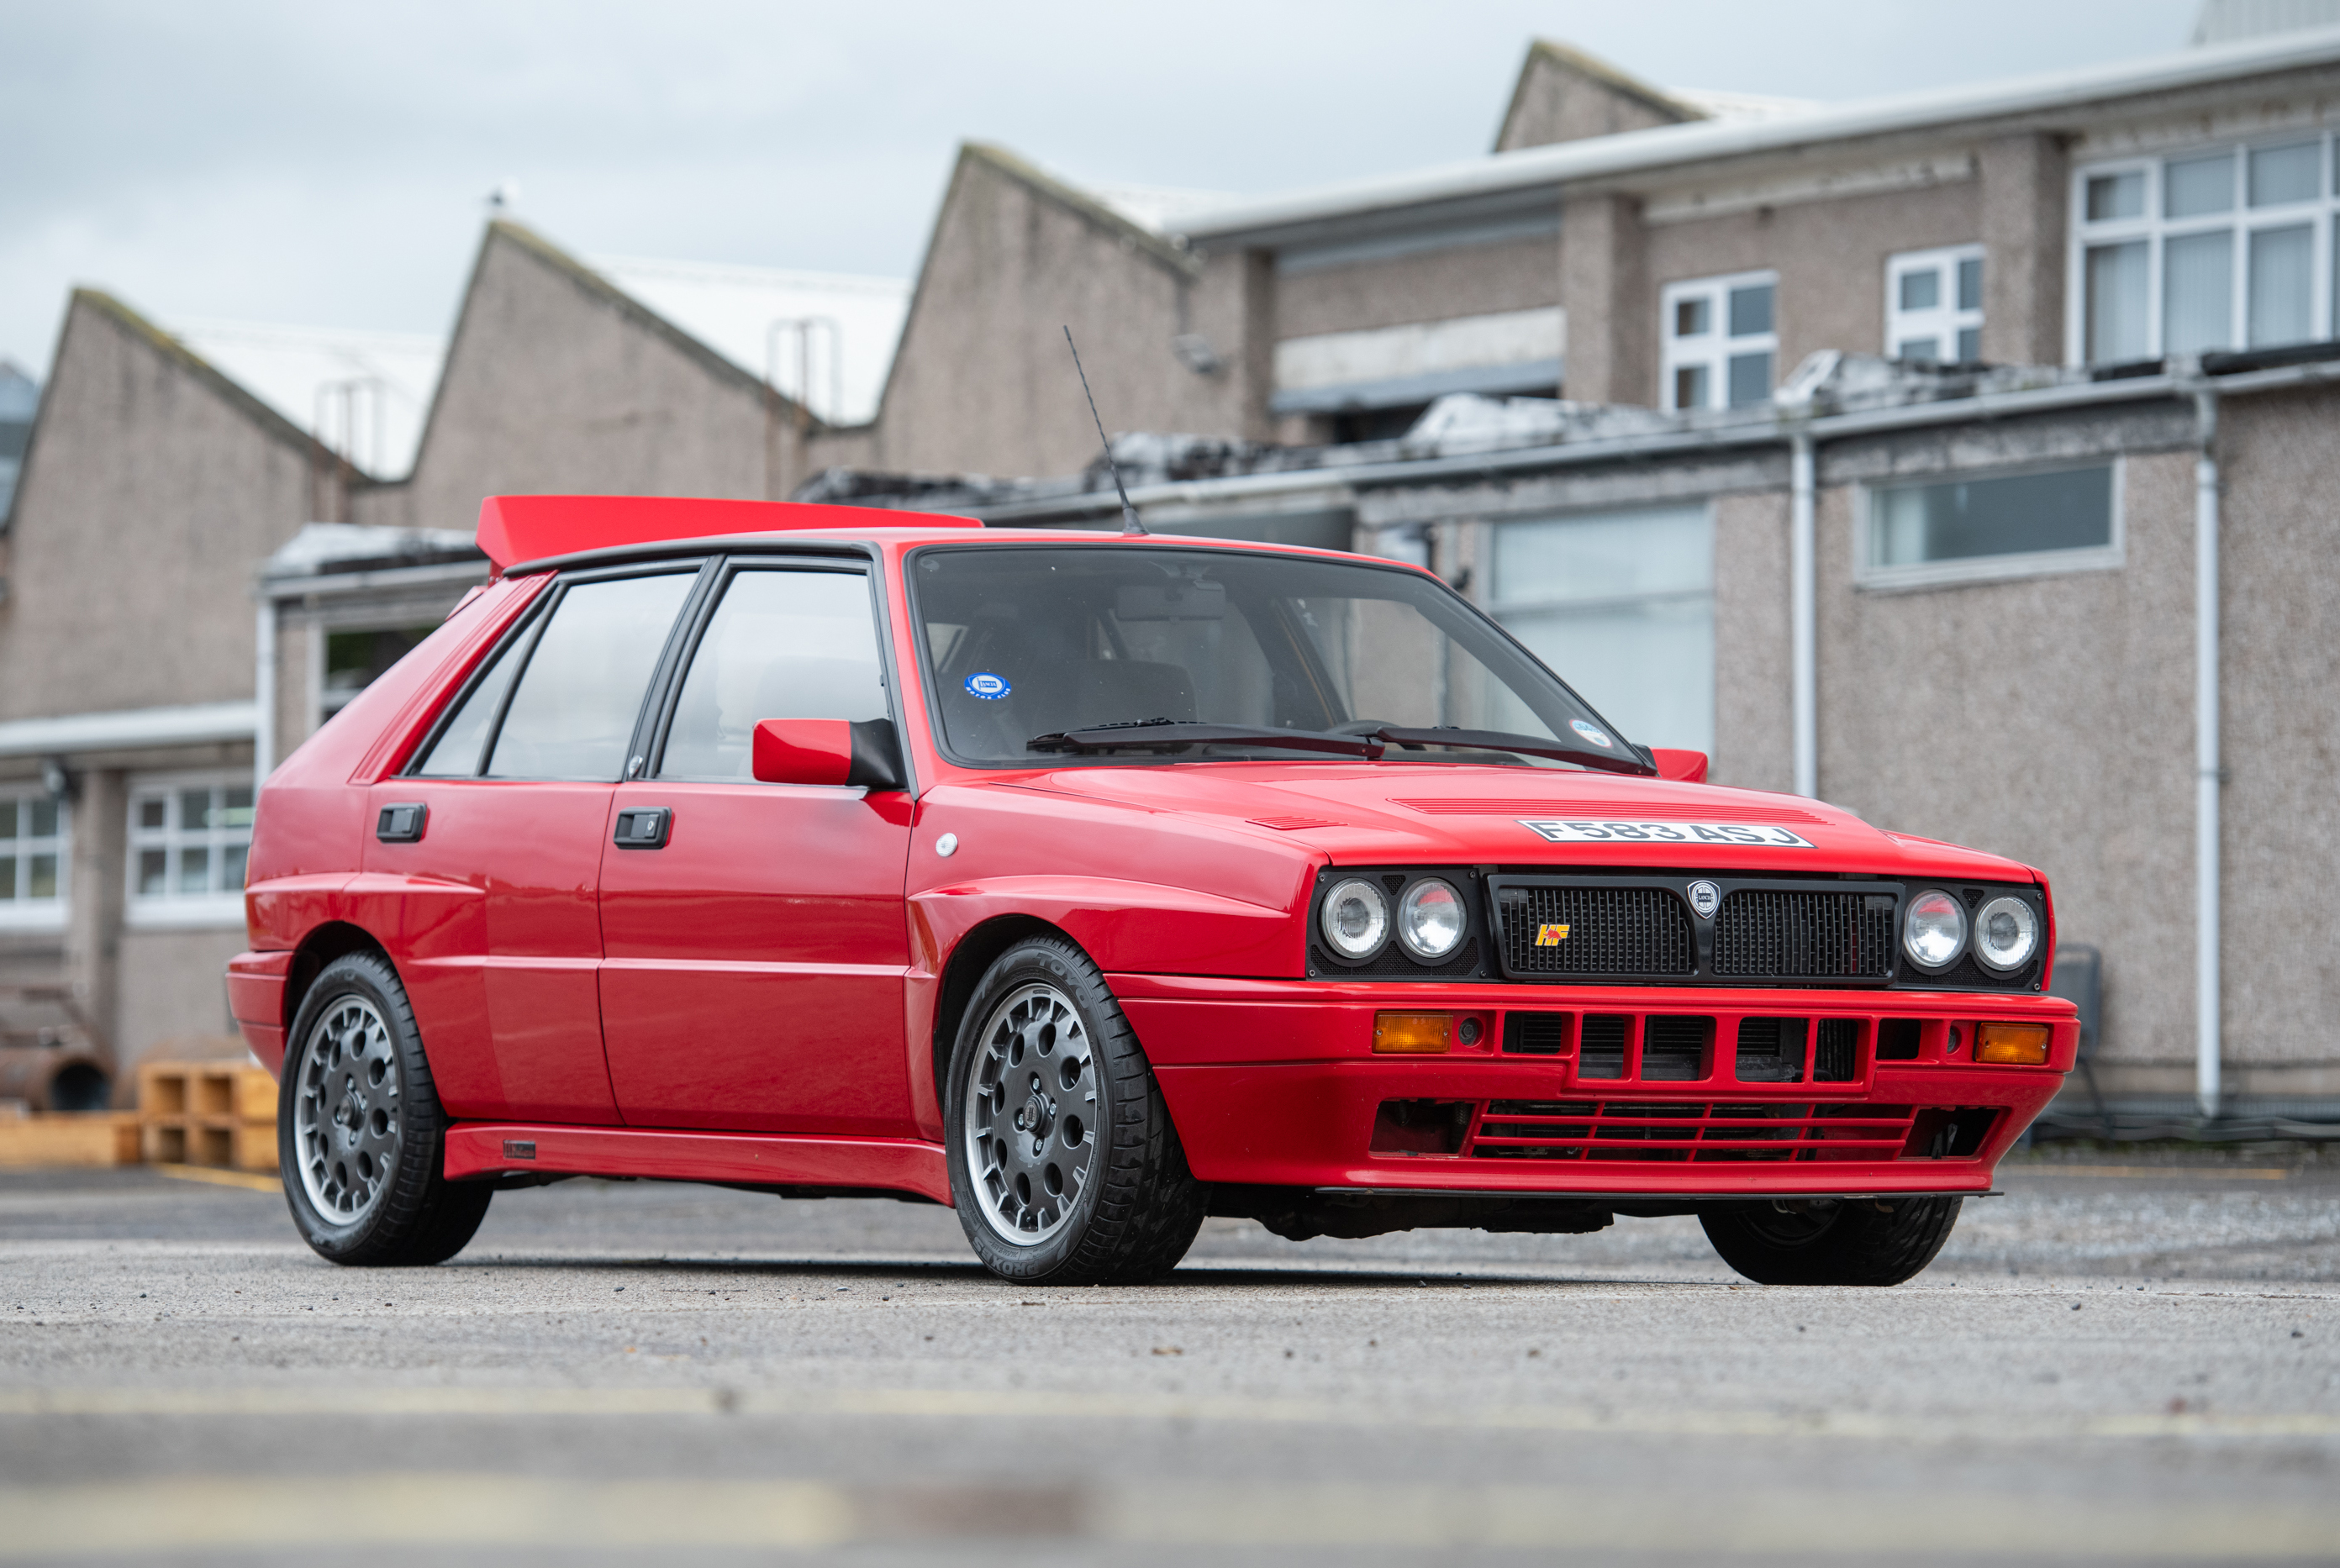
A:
[[447, 1121, 950, 1205]]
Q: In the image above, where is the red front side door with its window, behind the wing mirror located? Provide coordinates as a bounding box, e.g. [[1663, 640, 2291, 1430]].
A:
[[601, 560, 913, 1135]]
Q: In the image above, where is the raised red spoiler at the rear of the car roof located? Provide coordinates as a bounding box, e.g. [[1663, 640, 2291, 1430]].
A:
[[480, 496, 983, 573]]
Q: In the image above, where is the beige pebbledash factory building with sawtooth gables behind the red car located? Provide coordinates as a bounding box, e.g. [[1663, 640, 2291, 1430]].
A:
[[0, 15, 2340, 1126]]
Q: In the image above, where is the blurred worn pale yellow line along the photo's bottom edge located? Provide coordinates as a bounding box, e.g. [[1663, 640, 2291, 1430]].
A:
[[0, 1472, 2340, 1561]]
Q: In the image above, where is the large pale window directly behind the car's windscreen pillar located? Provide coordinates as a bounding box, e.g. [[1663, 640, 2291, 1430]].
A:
[[1489, 506, 1715, 751]]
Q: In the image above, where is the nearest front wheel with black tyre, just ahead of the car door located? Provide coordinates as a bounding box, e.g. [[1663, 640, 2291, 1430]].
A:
[[943, 939, 1203, 1285]]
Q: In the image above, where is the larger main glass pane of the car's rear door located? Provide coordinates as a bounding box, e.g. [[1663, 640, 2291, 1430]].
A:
[[487, 571, 693, 779]]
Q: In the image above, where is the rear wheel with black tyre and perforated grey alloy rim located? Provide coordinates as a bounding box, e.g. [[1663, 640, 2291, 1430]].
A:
[[277, 953, 496, 1269]]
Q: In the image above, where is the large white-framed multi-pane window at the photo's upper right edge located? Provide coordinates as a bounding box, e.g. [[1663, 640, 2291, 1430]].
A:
[[2066, 134, 2340, 365]]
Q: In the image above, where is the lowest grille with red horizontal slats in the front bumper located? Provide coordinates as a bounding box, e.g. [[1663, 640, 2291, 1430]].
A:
[[1462, 1100, 1912, 1163]]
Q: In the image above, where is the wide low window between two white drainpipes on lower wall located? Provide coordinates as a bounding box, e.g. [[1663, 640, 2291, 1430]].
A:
[[1856, 463, 2120, 587]]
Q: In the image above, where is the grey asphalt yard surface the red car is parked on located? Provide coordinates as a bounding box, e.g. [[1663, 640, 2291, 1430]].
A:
[[0, 1151, 2340, 1563]]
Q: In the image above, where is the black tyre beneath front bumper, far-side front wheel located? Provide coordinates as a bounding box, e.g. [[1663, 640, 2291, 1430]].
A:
[[1699, 1198, 1961, 1285]]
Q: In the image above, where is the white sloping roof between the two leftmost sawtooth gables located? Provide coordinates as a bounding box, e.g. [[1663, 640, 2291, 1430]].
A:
[[173, 321, 447, 480]]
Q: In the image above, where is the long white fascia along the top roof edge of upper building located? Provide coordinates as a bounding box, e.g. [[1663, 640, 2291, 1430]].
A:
[[1184, 28, 2340, 244]]
